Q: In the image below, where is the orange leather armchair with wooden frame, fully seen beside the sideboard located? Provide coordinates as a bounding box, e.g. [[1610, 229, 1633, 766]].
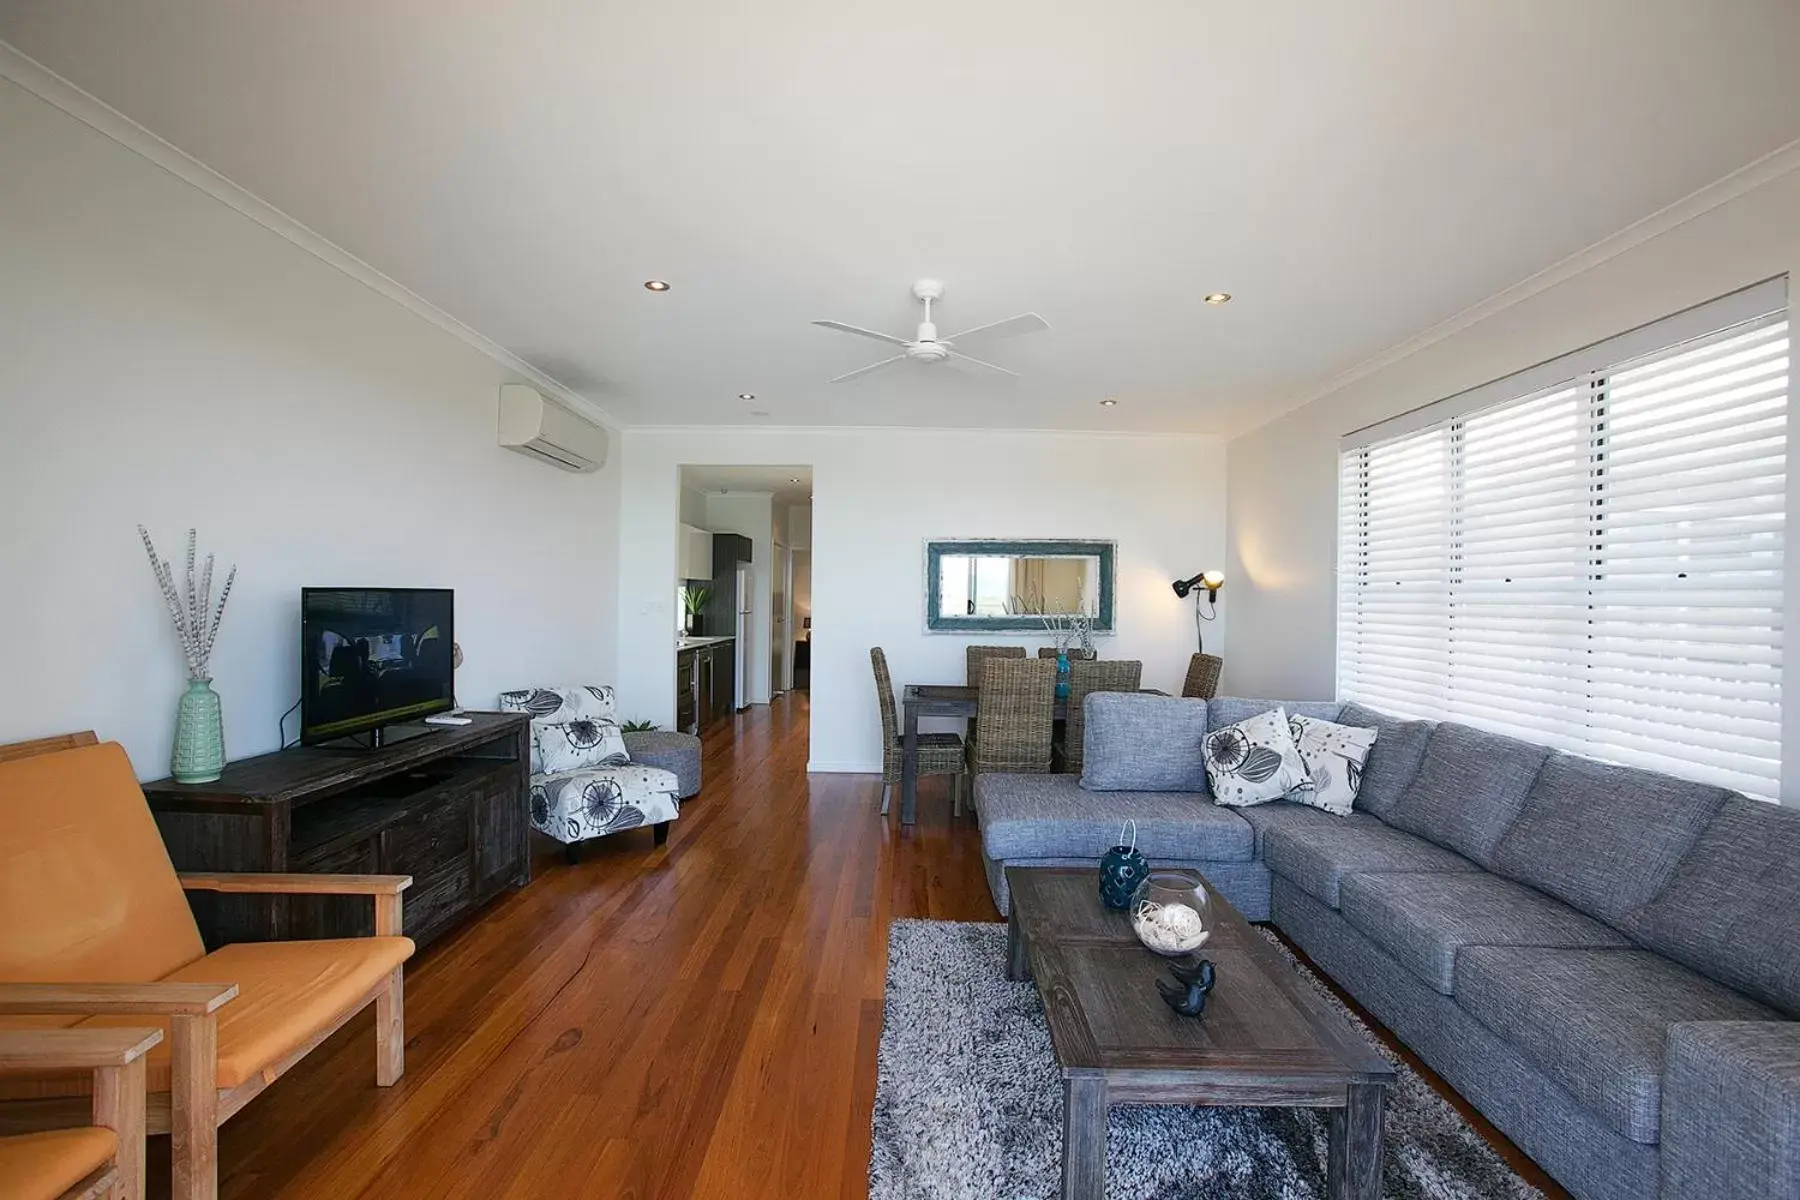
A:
[[0, 734, 412, 1200]]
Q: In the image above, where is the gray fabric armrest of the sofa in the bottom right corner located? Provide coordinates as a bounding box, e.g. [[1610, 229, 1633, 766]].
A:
[[1661, 1022, 1800, 1200]]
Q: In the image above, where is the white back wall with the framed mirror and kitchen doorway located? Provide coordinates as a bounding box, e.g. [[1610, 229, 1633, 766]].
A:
[[617, 430, 1229, 770]]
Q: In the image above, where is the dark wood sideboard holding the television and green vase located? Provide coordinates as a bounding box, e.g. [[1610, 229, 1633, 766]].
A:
[[144, 712, 531, 948]]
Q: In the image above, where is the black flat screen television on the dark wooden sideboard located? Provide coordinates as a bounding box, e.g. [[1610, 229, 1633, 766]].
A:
[[301, 588, 455, 745]]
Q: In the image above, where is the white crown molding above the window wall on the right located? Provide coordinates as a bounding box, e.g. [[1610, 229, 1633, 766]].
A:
[[1229, 139, 1800, 437]]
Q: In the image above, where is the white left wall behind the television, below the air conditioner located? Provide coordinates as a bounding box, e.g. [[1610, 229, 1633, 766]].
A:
[[0, 81, 626, 777]]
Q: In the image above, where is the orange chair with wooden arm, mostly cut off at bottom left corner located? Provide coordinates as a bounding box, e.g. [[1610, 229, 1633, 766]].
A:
[[0, 1029, 162, 1200]]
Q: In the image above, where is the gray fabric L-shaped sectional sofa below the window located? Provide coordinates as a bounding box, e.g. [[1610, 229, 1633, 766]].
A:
[[974, 694, 1800, 1200]]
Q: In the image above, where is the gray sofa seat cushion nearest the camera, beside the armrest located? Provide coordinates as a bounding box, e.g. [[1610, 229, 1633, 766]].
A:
[[1456, 946, 1778, 1144]]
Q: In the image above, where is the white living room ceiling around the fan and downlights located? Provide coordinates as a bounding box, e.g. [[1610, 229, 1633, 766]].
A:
[[0, 0, 1800, 432]]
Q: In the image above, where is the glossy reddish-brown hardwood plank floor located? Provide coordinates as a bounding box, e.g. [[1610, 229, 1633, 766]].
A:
[[151, 693, 1562, 1200]]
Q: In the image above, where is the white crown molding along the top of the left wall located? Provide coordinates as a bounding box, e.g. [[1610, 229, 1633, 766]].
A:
[[0, 41, 625, 432]]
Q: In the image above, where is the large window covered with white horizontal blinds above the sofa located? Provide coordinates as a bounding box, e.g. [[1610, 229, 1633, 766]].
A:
[[1337, 281, 1787, 799]]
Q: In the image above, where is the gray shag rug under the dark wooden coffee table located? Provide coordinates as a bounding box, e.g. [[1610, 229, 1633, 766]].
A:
[[869, 921, 1543, 1200]]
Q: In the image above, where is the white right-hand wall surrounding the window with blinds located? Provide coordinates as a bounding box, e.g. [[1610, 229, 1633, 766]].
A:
[[1226, 159, 1800, 759]]
